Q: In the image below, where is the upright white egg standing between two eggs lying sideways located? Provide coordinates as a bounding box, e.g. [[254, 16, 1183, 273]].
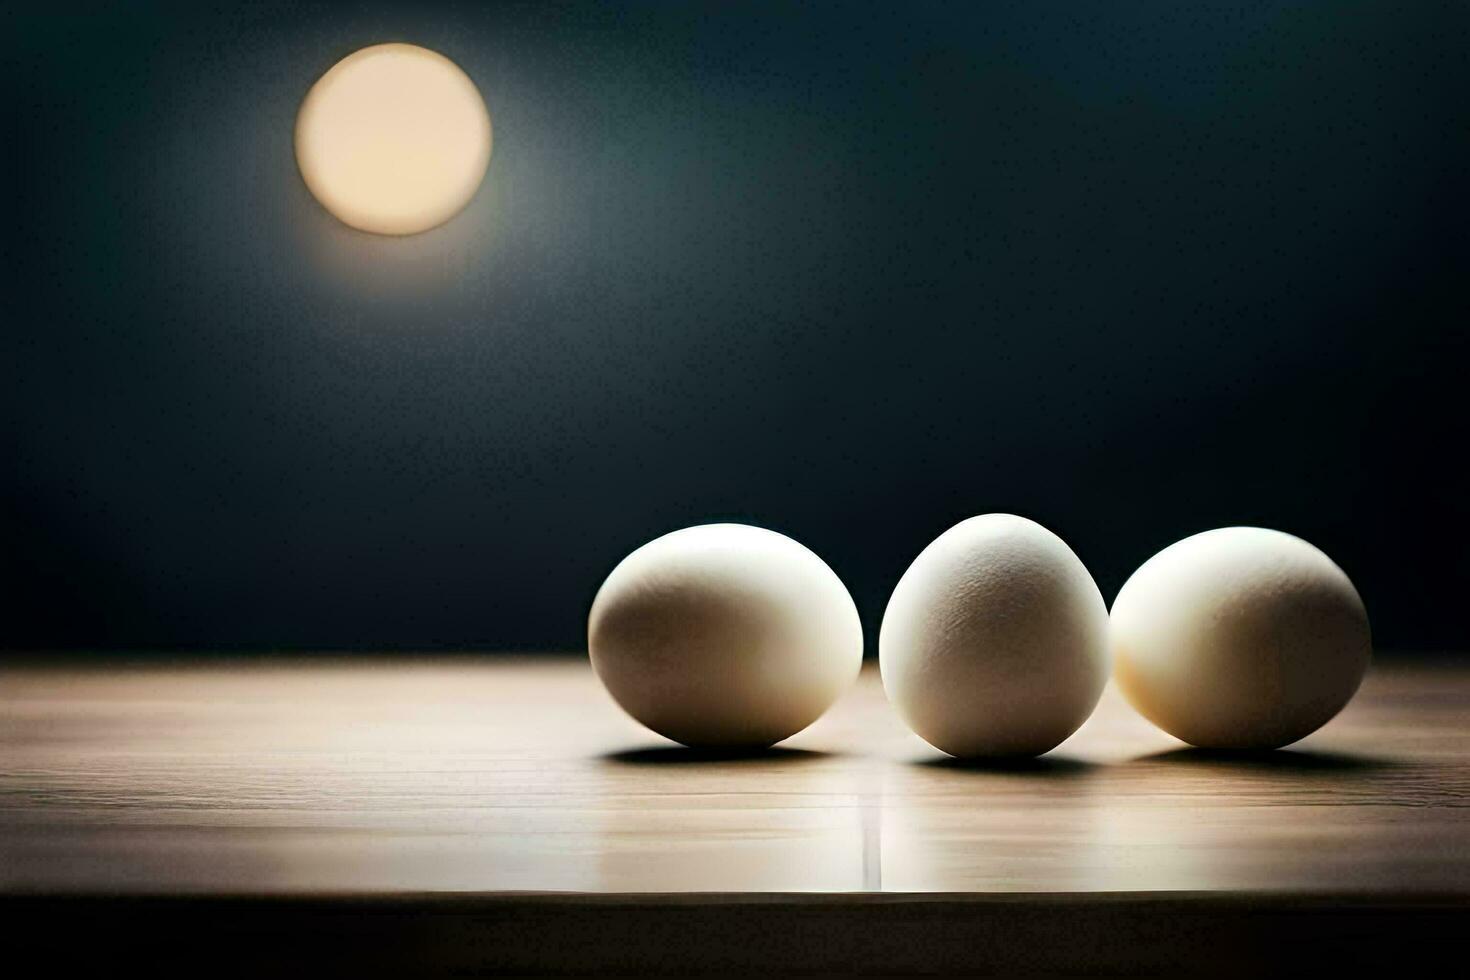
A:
[[879, 514, 1108, 757]]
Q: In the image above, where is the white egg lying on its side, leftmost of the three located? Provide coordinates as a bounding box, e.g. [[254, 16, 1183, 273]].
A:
[[587, 525, 863, 746]]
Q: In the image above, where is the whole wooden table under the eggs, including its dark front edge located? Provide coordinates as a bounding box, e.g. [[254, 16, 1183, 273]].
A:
[[0, 657, 1470, 973]]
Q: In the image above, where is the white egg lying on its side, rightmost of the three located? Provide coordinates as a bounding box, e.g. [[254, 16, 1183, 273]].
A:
[[1111, 527, 1373, 749]]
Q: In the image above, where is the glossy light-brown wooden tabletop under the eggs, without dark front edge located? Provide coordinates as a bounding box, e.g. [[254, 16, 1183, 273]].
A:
[[0, 657, 1470, 896]]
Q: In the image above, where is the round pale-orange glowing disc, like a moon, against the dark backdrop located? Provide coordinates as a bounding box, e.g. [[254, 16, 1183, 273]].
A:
[[295, 44, 491, 235]]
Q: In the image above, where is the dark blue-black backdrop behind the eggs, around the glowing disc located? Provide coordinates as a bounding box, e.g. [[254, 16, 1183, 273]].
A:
[[0, 0, 1470, 649]]
